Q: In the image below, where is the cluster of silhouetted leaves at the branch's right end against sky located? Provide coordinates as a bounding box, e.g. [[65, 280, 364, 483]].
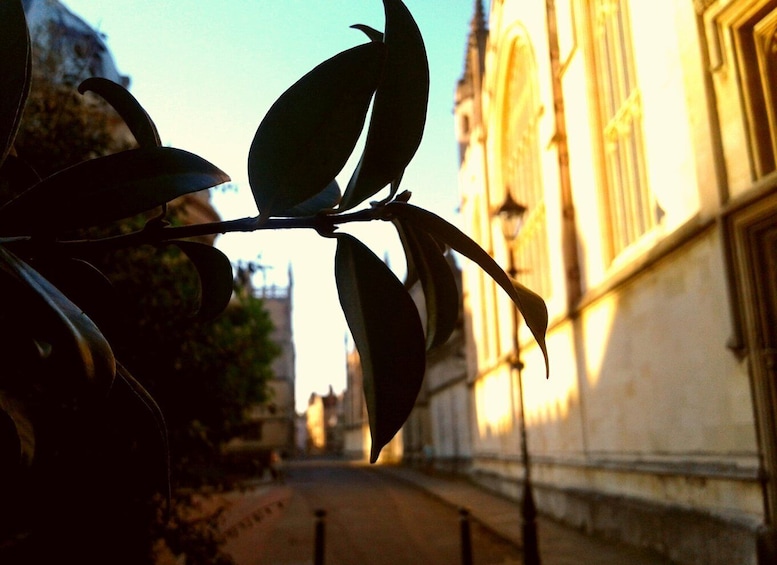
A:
[[242, 0, 547, 461]]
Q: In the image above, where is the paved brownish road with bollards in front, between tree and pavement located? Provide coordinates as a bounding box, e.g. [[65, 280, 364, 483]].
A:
[[233, 462, 520, 565]]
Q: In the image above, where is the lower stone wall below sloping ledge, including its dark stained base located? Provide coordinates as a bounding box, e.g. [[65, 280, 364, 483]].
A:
[[476, 230, 763, 563]]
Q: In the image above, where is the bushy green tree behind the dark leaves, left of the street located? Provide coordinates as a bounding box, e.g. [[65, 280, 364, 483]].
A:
[[87, 234, 279, 484]]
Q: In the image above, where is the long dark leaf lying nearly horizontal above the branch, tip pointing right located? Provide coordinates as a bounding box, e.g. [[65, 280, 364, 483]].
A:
[[0, 147, 229, 235]]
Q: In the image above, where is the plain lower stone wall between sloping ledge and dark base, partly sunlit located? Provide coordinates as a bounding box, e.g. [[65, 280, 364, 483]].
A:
[[475, 231, 756, 457]]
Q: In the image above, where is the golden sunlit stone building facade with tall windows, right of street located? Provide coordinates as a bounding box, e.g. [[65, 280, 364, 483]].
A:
[[455, 0, 777, 564]]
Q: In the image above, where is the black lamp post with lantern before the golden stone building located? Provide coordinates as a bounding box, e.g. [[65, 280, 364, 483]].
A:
[[496, 189, 540, 565]]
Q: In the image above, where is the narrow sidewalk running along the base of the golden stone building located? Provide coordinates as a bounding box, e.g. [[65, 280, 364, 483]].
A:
[[376, 467, 671, 565]]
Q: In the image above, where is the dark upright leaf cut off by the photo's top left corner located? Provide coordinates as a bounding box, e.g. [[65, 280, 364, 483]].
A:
[[0, 0, 31, 164]]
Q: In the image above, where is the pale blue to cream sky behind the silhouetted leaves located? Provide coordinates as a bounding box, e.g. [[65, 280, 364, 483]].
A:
[[63, 0, 474, 410]]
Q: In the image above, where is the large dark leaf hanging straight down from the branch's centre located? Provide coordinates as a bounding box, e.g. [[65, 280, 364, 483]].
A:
[[335, 234, 426, 463]]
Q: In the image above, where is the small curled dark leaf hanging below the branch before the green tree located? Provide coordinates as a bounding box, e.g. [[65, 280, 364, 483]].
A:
[[171, 241, 234, 320]]
